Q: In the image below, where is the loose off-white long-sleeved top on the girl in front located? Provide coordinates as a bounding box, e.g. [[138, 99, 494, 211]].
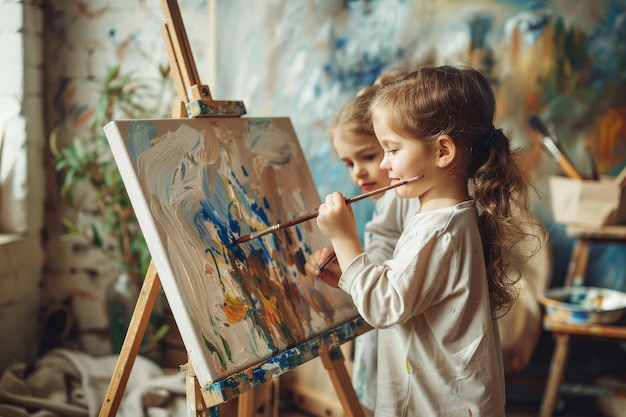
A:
[[339, 201, 505, 417]]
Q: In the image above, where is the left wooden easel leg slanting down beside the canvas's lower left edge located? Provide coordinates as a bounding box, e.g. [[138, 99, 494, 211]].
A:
[[99, 262, 160, 417]]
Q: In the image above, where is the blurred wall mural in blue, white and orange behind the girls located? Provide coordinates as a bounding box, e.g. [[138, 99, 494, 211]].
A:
[[213, 0, 626, 290]]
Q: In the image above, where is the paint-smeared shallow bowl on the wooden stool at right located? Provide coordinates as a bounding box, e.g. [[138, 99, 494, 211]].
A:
[[540, 287, 626, 324]]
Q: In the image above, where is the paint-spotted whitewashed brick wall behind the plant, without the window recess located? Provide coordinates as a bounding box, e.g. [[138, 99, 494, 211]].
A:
[[41, 0, 208, 355]]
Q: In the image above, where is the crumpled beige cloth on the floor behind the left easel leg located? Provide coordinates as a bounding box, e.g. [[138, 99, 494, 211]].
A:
[[0, 349, 186, 417]]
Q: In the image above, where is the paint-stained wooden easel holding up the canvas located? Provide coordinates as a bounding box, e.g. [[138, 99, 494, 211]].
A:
[[99, 0, 370, 417]]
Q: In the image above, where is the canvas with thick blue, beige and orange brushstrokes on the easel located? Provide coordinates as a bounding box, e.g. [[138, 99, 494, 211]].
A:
[[104, 117, 358, 385]]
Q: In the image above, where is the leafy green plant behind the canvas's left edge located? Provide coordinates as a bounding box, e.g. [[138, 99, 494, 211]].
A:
[[50, 67, 169, 286]]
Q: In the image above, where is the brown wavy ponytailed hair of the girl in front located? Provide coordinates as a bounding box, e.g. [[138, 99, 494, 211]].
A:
[[371, 66, 545, 312]]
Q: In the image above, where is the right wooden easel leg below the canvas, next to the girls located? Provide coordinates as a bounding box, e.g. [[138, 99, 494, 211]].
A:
[[321, 348, 365, 417]]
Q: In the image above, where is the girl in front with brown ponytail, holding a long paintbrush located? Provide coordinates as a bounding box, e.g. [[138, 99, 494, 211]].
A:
[[317, 66, 544, 417]]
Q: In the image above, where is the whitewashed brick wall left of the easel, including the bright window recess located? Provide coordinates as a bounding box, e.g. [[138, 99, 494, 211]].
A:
[[0, 0, 210, 371]]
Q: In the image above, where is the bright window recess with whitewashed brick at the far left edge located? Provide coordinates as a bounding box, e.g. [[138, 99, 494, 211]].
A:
[[0, 0, 44, 370]]
